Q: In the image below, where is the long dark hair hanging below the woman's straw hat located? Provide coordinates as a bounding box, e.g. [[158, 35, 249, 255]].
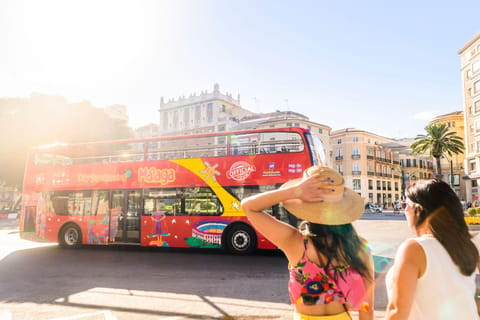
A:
[[306, 222, 372, 280]]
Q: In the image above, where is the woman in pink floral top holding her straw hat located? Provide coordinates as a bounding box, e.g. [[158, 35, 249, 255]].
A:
[[242, 166, 374, 320]]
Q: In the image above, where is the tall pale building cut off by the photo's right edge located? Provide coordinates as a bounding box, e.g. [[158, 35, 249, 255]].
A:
[[458, 33, 480, 202]]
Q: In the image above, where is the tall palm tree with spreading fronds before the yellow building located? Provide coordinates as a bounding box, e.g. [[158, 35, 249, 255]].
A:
[[410, 123, 465, 176]]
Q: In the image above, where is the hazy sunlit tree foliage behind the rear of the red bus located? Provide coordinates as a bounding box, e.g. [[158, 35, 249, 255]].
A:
[[0, 94, 133, 187]]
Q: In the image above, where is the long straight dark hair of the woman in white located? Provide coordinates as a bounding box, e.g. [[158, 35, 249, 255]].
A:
[[406, 179, 479, 276]]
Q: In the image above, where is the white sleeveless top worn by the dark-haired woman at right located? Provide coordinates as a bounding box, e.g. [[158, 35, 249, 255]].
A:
[[385, 237, 479, 320]]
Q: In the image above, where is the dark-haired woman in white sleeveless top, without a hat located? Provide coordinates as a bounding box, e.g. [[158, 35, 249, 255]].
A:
[[386, 179, 479, 320]]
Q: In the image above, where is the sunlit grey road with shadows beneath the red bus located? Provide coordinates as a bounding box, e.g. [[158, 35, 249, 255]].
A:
[[0, 215, 420, 320]]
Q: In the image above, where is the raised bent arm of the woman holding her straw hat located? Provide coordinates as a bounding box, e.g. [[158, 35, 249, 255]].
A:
[[242, 175, 328, 259]]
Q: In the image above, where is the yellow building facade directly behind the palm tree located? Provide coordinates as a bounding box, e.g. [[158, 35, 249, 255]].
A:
[[430, 111, 466, 199]]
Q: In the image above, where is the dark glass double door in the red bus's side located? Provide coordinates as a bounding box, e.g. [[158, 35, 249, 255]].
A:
[[110, 190, 142, 243]]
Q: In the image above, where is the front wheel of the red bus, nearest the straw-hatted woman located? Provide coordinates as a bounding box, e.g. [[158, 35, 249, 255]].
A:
[[224, 223, 257, 254]]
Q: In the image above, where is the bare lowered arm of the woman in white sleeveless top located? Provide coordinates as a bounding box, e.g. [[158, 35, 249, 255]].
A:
[[385, 239, 426, 320]]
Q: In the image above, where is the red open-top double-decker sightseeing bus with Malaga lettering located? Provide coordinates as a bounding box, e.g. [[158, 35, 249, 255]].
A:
[[20, 127, 324, 254]]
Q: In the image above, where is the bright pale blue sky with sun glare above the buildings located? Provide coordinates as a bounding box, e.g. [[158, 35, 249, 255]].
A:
[[0, 0, 480, 138]]
